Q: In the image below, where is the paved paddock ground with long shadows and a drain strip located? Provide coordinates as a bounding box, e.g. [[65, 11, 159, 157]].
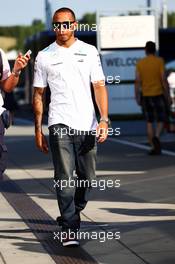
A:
[[0, 117, 175, 264]]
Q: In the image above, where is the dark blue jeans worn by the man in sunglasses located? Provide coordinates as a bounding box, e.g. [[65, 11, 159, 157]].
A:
[[49, 124, 97, 230]]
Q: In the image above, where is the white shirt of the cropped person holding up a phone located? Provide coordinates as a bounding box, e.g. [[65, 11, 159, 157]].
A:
[[0, 49, 11, 115]]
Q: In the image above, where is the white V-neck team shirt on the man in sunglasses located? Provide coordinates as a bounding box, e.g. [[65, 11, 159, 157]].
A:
[[34, 39, 105, 131]]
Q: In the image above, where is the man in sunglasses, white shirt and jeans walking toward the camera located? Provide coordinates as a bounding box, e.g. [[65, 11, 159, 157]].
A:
[[33, 8, 108, 246]]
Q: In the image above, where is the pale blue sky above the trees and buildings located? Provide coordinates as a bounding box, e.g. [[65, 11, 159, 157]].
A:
[[0, 0, 175, 26]]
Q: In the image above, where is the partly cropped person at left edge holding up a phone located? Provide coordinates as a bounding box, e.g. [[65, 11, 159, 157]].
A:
[[0, 49, 30, 179]]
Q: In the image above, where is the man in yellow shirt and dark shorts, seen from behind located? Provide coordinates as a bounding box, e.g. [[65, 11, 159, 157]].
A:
[[135, 41, 169, 155]]
